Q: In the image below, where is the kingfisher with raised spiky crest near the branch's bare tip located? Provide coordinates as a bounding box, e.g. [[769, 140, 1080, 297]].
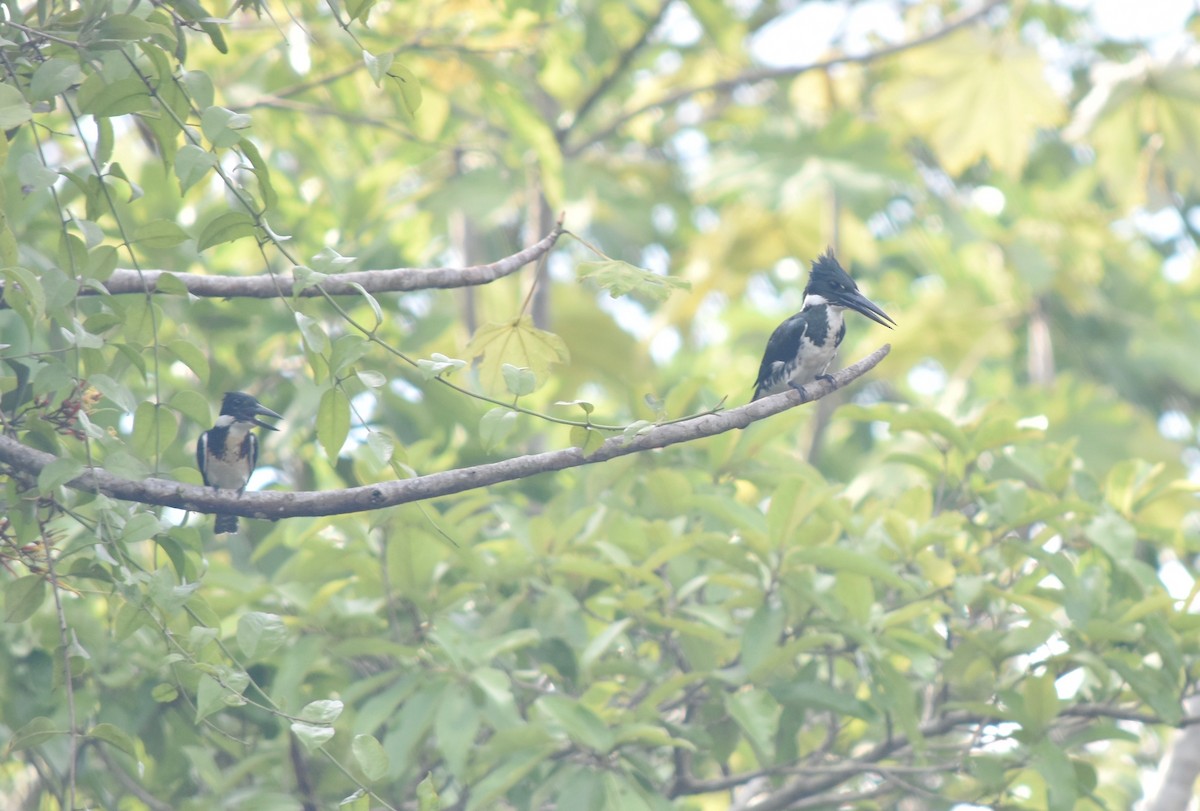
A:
[[751, 248, 895, 402]]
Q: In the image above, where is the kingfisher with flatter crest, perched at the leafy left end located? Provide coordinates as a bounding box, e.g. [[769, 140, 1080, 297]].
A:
[[196, 391, 283, 534]]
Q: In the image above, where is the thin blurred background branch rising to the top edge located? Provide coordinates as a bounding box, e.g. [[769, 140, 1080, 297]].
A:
[[563, 0, 1007, 156]]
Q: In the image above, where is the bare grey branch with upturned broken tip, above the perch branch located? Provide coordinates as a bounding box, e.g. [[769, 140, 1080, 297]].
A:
[[23, 218, 563, 299]]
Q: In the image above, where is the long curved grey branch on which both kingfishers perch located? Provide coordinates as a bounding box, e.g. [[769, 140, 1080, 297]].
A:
[[0, 344, 892, 519]]
